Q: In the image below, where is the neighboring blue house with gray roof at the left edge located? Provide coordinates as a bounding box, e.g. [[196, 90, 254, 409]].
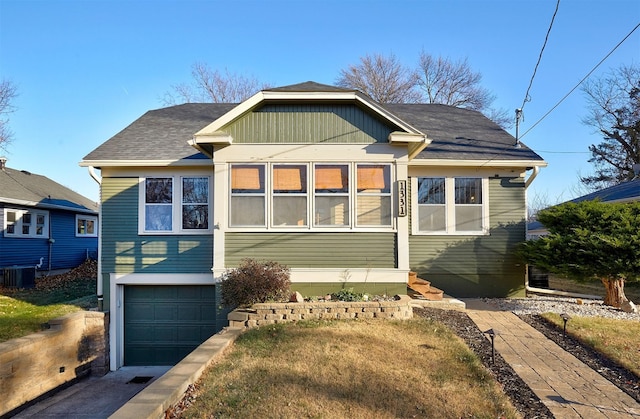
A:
[[0, 158, 99, 273]]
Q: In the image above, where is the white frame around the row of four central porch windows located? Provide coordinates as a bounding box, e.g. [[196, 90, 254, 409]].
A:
[[226, 161, 397, 231]]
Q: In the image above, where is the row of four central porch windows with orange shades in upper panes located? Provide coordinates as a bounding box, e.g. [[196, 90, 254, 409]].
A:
[[229, 163, 393, 229]]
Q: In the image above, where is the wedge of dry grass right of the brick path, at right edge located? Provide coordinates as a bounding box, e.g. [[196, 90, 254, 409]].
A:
[[542, 313, 640, 377]]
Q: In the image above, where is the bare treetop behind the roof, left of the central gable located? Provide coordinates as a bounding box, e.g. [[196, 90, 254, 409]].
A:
[[161, 63, 270, 106]]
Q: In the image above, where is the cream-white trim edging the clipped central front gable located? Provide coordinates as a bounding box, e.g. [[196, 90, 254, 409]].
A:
[[194, 91, 424, 144]]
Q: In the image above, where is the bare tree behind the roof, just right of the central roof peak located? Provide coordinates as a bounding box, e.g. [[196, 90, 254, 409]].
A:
[[336, 54, 421, 104]]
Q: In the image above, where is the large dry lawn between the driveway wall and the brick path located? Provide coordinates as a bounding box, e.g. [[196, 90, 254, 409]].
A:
[[183, 319, 518, 418]]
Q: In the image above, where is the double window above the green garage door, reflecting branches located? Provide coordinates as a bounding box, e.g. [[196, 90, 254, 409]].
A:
[[140, 176, 211, 234]]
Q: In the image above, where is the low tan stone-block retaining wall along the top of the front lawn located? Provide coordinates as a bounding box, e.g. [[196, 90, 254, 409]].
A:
[[228, 296, 413, 328]]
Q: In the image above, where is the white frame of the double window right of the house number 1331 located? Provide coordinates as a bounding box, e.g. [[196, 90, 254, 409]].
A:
[[411, 174, 490, 236]]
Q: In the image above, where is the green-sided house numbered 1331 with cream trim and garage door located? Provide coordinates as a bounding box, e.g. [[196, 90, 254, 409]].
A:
[[80, 82, 546, 369]]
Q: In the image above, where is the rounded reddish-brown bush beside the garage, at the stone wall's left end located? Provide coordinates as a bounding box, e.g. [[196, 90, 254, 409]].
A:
[[220, 259, 291, 307]]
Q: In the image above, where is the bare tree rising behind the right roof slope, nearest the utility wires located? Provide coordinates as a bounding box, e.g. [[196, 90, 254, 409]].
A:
[[417, 50, 514, 128]]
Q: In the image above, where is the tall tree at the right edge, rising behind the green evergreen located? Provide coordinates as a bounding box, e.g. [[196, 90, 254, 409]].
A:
[[580, 65, 640, 189]]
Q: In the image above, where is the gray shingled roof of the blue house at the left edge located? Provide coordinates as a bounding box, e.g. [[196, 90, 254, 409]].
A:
[[0, 167, 98, 213]]
